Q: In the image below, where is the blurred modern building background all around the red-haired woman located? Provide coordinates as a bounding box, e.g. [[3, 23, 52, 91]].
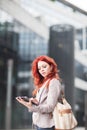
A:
[[0, 0, 87, 130]]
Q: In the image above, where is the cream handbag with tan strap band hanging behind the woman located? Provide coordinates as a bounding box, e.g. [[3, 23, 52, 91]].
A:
[[53, 97, 77, 130]]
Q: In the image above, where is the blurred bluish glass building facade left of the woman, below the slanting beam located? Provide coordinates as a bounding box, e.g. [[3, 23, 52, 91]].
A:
[[0, 10, 48, 129]]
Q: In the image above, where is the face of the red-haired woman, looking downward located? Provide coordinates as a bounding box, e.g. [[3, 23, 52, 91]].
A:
[[38, 61, 52, 78]]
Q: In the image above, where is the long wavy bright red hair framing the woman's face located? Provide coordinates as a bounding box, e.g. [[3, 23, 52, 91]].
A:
[[32, 55, 60, 94]]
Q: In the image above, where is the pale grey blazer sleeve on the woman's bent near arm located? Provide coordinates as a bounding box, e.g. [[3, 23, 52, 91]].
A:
[[29, 79, 61, 113]]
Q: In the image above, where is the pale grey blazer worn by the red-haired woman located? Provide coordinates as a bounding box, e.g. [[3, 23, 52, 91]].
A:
[[29, 78, 61, 128]]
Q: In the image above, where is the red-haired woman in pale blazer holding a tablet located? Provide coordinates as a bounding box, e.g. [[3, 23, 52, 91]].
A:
[[17, 56, 61, 130]]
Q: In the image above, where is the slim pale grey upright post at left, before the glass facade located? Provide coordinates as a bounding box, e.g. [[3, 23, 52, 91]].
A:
[[5, 59, 13, 130]]
